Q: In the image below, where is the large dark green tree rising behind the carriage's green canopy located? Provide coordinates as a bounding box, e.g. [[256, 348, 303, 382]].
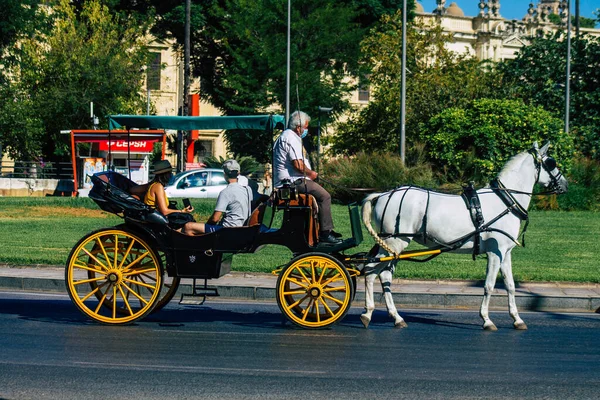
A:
[[146, 0, 412, 162]]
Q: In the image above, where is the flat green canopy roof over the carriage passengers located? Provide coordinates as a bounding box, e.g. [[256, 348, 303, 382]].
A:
[[108, 115, 284, 131]]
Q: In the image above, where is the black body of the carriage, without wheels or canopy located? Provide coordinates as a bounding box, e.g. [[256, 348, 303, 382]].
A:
[[89, 171, 362, 279]]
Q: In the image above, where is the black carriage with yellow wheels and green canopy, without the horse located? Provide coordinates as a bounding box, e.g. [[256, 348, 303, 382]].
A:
[[65, 116, 362, 328]]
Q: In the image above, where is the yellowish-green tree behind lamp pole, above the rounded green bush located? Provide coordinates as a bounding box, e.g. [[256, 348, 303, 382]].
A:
[[330, 12, 500, 155]]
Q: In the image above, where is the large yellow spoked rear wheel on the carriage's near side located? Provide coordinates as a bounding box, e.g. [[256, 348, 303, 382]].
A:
[[65, 229, 163, 325]]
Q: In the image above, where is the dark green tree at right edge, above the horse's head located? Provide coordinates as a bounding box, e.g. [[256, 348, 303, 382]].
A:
[[499, 32, 600, 158]]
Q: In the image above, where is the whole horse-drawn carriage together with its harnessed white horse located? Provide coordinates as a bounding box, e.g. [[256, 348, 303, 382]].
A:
[[66, 116, 567, 330]]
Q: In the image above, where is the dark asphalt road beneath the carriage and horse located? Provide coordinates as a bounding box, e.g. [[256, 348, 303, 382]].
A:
[[0, 292, 600, 399]]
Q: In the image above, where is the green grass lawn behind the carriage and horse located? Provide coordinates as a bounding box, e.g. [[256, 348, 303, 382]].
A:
[[0, 197, 600, 282]]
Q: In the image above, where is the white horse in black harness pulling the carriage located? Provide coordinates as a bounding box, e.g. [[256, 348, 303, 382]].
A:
[[360, 143, 568, 330]]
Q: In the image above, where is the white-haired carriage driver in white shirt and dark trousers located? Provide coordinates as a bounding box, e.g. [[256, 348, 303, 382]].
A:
[[273, 111, 341, 244]]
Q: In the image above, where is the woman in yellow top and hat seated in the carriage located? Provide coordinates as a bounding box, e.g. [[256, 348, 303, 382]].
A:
[[144, 160, 204, 235]]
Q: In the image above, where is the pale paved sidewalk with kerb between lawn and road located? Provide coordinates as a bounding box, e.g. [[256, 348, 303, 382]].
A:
[[0, 266, 600, 312]]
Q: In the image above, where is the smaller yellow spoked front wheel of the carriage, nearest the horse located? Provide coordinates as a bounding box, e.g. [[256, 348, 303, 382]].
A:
[[277, 253, 354, 329]]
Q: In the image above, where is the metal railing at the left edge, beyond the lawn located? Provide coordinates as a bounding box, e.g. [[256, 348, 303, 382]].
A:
[[0, 161, 73, 179]]
